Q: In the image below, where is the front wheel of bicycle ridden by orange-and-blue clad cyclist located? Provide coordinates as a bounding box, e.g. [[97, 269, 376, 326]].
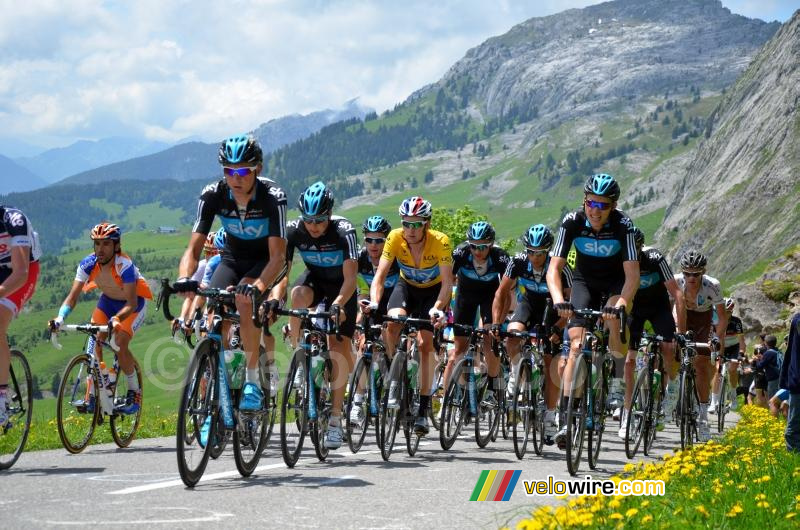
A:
[[56, 353, 100, 454]]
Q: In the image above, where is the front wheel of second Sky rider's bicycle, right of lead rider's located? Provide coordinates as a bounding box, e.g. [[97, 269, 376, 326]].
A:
[[281, 348, 308, 467]]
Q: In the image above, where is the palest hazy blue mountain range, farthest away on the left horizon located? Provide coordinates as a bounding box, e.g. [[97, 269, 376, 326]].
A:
[[16, 137, 169, 182]]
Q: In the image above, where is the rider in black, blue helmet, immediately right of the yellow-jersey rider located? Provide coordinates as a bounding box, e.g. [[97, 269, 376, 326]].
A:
[[443, 221, 509, 403]]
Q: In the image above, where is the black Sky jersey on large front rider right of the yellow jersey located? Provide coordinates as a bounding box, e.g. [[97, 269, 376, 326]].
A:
[[552, 210, 637, 282]]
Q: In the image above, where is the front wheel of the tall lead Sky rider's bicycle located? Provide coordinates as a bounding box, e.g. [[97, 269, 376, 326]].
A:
[[176, 339, 219, 488]]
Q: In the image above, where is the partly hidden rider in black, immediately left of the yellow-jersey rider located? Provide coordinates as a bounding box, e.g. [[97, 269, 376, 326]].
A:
[[350, 215, 400, 425]]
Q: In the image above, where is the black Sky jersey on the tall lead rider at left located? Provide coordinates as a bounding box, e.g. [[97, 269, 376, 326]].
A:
[[192, 177, 286, 261]]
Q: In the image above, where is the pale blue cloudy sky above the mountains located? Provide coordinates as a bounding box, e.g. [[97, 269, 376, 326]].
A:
[[0, 0, 797, 156]]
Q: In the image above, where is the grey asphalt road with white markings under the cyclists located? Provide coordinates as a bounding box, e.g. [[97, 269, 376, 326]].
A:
[[0, 414, 738, 529]]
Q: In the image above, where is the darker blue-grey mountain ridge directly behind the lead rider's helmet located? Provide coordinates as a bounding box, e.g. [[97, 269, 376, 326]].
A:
[[56, 99, 374, 184]]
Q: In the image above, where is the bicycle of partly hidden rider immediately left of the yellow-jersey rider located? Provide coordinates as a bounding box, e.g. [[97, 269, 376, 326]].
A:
[[345, 314, 389, 453]]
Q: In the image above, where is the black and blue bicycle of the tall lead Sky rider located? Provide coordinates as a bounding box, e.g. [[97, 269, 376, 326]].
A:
[[156, 278, 276, 488]]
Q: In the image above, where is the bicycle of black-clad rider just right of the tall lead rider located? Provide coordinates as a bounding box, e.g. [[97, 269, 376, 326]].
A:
[[274, 309, 341, 468]]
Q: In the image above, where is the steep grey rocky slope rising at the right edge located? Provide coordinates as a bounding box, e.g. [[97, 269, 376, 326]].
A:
[[659, 11, 800, 274]]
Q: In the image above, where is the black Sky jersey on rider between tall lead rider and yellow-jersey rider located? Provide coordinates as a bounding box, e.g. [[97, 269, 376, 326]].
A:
[[286, 215, 358, 285]]
